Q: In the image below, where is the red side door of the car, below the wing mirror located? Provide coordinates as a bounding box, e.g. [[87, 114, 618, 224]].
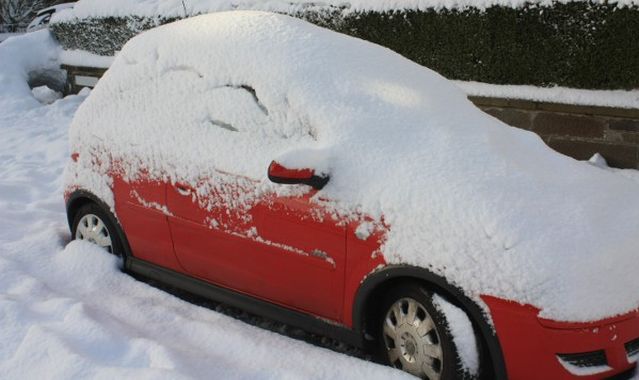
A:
[[167, 175, 346, 320]]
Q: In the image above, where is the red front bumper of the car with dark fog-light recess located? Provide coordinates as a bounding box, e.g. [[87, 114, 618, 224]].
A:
[[482, 296, 639, 380]]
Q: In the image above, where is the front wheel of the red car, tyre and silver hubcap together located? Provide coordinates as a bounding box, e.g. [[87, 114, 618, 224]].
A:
[[377, 283, 471, 380]]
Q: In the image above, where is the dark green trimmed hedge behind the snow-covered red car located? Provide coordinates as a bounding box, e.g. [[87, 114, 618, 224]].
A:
[[51, 1, 639, 89]]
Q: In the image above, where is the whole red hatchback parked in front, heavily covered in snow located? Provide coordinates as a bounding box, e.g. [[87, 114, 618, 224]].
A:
[[65, 12, 639, 379]]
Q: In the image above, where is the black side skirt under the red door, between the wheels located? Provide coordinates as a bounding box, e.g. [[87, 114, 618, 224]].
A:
[[125, 256, 364, 348]]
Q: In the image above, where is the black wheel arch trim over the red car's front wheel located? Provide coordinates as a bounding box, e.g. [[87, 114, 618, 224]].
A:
[[353, 265, 507, 379]]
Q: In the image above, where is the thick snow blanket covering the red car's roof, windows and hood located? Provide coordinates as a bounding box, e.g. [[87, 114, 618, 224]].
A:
[[68, 11, 639, 321]]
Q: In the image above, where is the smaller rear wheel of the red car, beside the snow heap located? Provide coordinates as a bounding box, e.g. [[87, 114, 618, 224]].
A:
[[71, 203, 126, 259]]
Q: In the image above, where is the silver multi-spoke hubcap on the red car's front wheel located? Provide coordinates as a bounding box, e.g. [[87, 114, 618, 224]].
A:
[[384, 298, 443, 380]]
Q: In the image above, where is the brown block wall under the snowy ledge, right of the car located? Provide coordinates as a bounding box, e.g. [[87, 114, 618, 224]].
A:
[[470, 97, 639, 169]]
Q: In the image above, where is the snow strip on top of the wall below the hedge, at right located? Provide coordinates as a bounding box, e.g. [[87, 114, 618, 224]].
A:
[[453, 81, 639, 109]]
